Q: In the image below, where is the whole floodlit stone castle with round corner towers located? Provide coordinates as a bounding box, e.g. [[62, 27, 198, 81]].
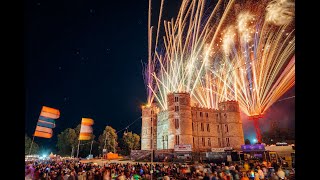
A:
[[141, 93, 244, 152]]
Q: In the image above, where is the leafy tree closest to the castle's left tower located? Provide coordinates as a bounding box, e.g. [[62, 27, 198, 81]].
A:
[[121, 132, 140, 155]]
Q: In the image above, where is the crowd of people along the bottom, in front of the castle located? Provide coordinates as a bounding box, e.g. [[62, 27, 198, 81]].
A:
[[25, 159, 295, 180]]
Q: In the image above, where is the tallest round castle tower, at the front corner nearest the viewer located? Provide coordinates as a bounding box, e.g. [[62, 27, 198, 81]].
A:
[[168, 93, 193, 149]]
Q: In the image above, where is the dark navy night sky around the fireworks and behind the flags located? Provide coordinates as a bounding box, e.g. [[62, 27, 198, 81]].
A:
[[24, 0, 295, 150]]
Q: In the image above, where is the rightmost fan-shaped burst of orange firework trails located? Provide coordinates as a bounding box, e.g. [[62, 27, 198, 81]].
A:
[[220, 3, 295, 116]]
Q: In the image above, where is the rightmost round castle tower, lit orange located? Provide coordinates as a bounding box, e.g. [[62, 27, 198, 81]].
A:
[[218, 101, 244, 149]]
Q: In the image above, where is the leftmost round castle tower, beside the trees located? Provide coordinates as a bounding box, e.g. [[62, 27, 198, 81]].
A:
[[141, 104, 158, 150]]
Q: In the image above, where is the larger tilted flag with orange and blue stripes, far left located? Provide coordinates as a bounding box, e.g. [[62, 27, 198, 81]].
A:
[[34, 106, 60, 138]]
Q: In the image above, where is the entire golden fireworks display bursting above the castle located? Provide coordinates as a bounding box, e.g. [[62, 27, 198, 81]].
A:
[[145, 0, 295, 116]]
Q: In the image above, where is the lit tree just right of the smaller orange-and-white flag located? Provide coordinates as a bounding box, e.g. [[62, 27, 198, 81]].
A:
[[98, 126, 118, 152]]
